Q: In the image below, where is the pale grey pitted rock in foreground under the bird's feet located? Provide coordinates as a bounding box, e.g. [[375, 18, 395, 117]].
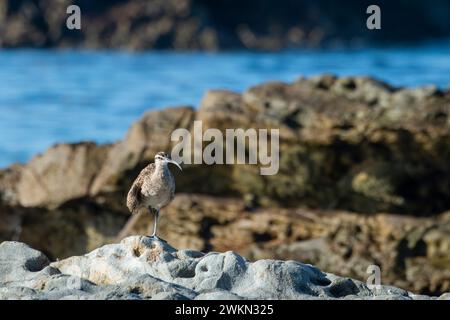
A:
[[0, 236, 448, 300]]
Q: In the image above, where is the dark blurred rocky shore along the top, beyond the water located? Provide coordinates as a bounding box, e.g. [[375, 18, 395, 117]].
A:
[[0, 0, 450, 50]]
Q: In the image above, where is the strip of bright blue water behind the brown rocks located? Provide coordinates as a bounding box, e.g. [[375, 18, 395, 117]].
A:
[[0, 42, 450, 167]]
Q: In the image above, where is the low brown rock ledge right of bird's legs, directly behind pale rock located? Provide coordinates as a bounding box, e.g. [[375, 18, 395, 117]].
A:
[[118, 194, 450, 294]]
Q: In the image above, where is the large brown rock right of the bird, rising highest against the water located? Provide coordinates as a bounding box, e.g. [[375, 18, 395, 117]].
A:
[[194, 75, 450, 215]]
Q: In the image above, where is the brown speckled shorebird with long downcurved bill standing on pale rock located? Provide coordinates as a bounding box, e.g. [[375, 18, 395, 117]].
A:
[[126, 152, 182, 239]]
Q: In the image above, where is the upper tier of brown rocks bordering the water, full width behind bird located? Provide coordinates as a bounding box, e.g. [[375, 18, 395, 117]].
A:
[[4, 75, 450, 215]]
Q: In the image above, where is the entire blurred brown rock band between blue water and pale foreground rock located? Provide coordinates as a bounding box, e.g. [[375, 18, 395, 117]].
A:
[[0, 75, 450, 294]]
